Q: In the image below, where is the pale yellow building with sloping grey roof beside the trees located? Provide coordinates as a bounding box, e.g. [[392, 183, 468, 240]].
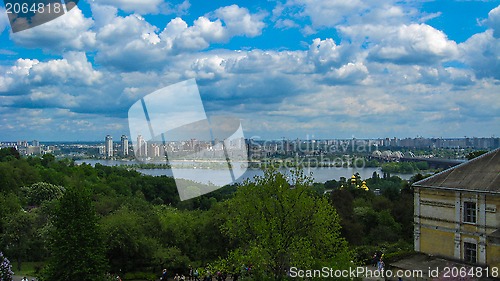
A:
[[413, 149, 500, 268]]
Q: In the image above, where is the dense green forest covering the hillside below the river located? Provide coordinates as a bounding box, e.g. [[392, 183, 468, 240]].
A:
[[0, 148, 422, 281]]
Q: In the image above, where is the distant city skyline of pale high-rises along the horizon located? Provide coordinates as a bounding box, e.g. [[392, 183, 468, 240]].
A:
[[0, 135, 500, 162]]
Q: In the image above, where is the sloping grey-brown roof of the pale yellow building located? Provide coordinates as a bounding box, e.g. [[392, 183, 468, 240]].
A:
[[413, 148, 500, 193]]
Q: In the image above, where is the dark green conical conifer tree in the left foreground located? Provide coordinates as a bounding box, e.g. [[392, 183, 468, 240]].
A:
[[43, 188, 107, 281]]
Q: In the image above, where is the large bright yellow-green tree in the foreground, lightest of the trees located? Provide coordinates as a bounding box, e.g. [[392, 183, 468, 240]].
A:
[[222, 170, 351, 280]]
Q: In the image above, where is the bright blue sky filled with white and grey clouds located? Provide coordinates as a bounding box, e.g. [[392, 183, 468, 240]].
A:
[[0, 0, 500, 141]]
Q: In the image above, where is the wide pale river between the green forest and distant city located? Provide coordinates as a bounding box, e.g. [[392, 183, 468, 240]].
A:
[[75, 159, 413, 186]]
